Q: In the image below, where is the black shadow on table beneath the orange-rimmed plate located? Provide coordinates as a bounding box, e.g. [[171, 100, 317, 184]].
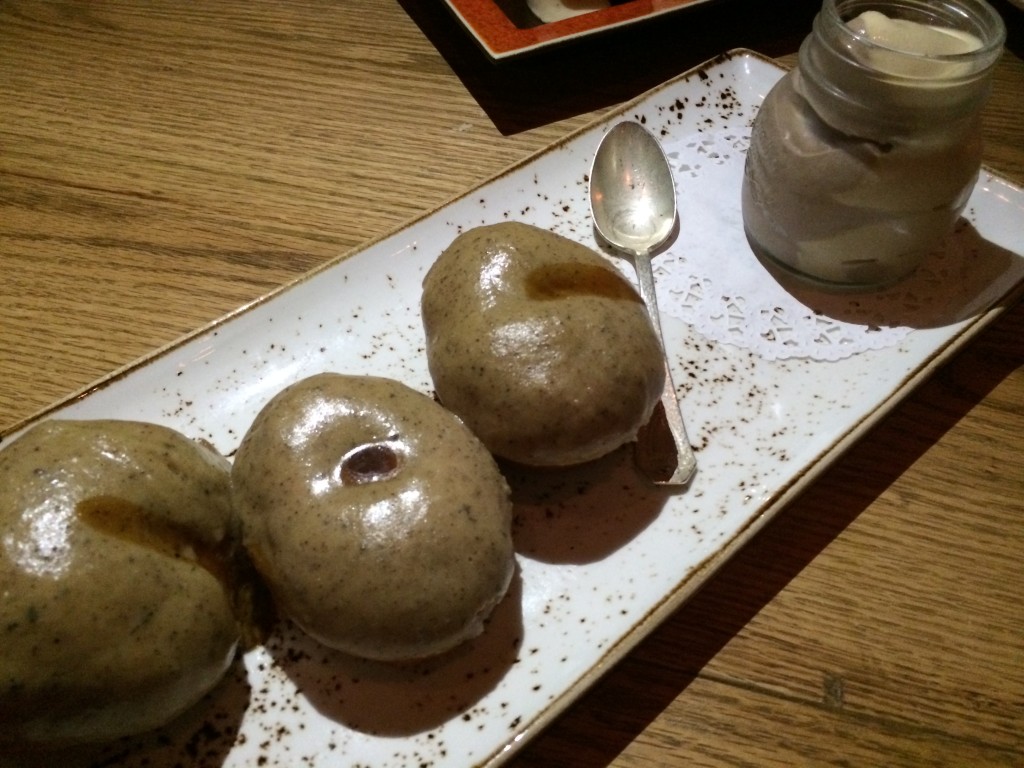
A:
[[398, 0, 821, 135]]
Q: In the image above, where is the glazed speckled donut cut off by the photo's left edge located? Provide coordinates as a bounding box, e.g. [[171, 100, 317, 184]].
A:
[[0, 421, 239, 746]]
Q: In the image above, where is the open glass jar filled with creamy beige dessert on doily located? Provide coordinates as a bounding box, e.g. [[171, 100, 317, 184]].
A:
[[742, 0, 1006, 289]]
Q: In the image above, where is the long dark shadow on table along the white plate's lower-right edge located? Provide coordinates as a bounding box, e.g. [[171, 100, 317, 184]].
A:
[[514, 290, 1024, 768]]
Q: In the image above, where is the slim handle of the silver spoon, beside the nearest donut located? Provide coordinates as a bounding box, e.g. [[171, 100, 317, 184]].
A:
[[633, 251, 697, 485]]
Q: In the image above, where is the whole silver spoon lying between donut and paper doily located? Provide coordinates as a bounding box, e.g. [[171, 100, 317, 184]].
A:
[[590, 121, 696, 485]]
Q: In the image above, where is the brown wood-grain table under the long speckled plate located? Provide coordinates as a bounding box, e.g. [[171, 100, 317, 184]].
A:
[[0, 0, 1024, 768]]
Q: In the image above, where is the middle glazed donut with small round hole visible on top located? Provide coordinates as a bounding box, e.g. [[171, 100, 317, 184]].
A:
[[232, 374, 514, 660]]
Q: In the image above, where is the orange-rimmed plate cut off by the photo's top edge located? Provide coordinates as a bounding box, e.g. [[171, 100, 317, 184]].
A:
[[444, 0, 709, 59]]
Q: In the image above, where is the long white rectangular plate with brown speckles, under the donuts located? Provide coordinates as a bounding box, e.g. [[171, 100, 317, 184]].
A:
[[6, 51, 1024, 768]]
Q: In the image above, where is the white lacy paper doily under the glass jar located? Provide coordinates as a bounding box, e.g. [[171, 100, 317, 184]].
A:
[[653, 128, 992, 360]]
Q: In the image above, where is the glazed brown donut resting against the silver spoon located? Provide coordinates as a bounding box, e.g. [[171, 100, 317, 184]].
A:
[[421, 222, 665, 466]]
